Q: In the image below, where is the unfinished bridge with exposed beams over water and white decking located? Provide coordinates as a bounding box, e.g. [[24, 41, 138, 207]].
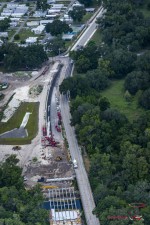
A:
[[48, 187, 81, 225]]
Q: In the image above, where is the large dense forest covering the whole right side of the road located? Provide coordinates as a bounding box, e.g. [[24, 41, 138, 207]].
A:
[[60, 0, 150, 225]]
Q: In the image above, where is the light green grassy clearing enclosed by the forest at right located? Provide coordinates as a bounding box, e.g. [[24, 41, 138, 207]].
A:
[[102, 80, 143, 121]]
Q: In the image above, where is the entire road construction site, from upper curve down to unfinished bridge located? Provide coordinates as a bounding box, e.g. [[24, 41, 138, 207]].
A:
[[0, 56, 82, 225]]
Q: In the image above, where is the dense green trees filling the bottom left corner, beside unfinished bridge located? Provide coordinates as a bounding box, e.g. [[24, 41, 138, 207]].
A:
[[0, 155, 49, 225]]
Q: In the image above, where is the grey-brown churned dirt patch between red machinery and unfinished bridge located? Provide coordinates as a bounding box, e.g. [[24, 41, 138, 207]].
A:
[[24, 144, 73, 187]]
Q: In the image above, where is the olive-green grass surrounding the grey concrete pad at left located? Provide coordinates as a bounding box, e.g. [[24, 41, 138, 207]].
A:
[[0, 102, 39, 144]]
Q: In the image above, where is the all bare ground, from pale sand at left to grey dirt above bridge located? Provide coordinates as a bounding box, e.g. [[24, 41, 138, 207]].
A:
[[0, 58, 74, 187]]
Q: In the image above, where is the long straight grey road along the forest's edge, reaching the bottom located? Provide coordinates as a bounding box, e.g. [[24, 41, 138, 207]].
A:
[[60, 95, 100, 225]]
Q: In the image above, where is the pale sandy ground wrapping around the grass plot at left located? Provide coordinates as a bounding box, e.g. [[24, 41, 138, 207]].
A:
[[0, 61, 59, 171]]
